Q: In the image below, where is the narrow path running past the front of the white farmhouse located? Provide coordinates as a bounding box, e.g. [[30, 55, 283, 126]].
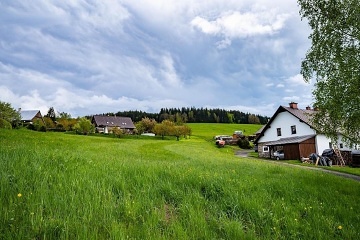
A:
[[235, 150, 360, 182]]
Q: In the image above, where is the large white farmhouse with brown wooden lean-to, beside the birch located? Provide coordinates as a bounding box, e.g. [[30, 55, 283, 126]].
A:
[[254, 102, 350, 159]]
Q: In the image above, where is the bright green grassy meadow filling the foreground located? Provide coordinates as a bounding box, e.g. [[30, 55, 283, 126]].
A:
[[0, 125, 360, 239]]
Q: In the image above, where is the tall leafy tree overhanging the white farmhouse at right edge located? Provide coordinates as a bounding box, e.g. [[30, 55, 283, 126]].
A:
[[298, 0, 360, 143]]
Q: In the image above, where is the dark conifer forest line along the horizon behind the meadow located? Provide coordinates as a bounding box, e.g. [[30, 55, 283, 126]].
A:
[[100, 107, 269, 124]]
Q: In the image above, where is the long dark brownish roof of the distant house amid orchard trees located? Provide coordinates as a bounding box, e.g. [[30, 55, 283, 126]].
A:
[[92, 115, 135, 129]]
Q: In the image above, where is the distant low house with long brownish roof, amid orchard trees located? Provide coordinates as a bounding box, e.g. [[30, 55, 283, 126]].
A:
[[91, 115, 135, 133]]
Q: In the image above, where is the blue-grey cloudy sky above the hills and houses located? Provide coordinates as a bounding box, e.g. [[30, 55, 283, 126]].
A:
[[0, 0, 313, 116]]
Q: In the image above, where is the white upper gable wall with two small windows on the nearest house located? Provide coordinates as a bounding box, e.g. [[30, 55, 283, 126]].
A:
[[261, 112, 316, 142]]
